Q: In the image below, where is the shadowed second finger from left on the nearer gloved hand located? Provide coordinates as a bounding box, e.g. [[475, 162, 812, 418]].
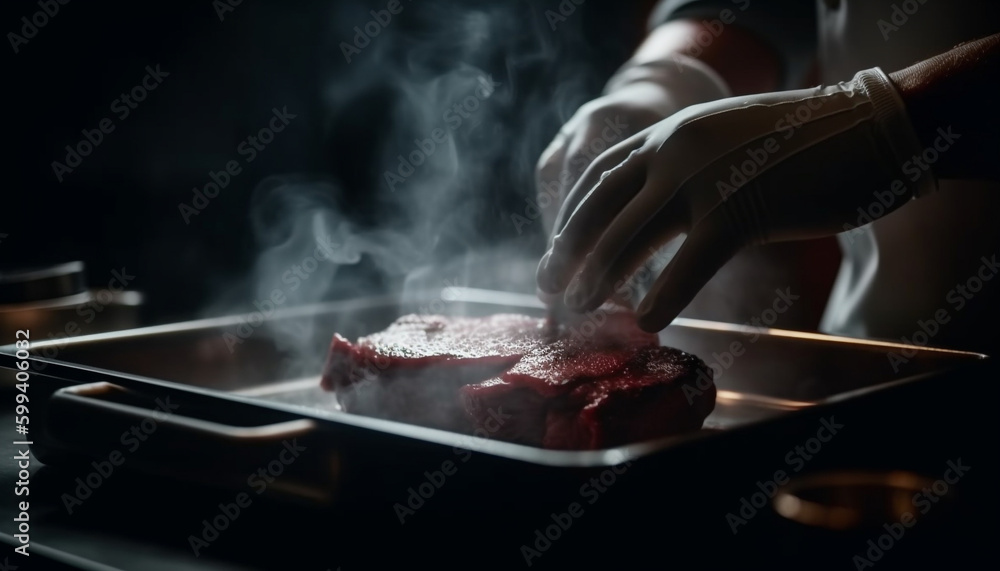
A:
[[565, 202, 689, 311]]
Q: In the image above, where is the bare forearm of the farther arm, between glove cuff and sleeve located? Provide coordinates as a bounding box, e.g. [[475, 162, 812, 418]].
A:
[[623, 19, 781, 95]]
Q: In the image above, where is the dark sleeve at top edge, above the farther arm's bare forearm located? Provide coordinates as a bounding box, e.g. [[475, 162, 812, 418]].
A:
[[649, 0, 819, 89]]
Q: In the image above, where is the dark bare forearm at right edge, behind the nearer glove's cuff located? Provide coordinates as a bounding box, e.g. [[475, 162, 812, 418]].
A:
[[889, 34, 1000, 180]]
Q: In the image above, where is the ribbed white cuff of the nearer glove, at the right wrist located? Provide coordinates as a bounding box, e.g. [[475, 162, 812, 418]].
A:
[[853, 67, 938, 198]]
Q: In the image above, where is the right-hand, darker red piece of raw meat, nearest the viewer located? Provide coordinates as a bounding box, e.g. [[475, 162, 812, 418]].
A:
[[461, 347, 715, 449]]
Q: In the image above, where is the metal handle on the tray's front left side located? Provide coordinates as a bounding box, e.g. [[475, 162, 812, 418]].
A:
[[46, 382, 340, 504]]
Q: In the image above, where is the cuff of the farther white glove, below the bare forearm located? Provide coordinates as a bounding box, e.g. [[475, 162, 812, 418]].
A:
[[604, 54, 732, 107]]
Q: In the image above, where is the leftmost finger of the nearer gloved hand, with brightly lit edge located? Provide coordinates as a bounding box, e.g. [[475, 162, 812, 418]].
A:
[[537, 137, 646, 293]]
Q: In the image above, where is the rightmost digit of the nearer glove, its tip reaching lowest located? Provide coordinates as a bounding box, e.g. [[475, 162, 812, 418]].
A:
[[637, 208, 742, 331]]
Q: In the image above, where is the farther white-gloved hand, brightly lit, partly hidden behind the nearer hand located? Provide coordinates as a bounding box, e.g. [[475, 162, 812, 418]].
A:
[[535, 55, 729, 231]]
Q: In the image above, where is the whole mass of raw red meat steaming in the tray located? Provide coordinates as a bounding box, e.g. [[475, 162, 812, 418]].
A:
[[322, 306, 715, 448]]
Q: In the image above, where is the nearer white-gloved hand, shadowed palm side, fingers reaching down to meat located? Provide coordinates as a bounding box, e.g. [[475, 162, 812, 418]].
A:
[[537, 68, 936, 331]]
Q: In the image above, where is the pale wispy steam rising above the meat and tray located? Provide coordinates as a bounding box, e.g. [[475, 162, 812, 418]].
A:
[[210, 1, 599, 380]]
